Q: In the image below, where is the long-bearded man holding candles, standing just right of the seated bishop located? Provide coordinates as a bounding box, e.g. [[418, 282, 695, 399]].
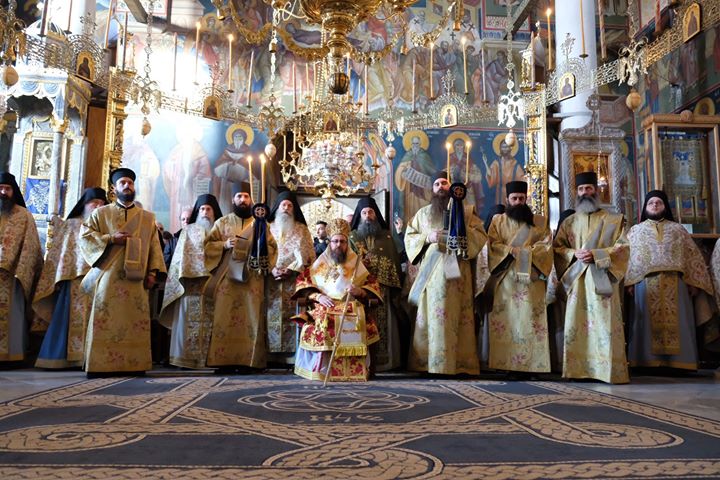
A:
[[405, 172, 487, 375]]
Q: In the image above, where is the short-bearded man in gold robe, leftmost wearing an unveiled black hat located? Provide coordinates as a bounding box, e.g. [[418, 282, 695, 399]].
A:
[[80, 168, 165, 376]]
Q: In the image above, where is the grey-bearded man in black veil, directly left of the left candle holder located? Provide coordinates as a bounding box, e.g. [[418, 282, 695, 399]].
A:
[[160, 194, 222, 368]]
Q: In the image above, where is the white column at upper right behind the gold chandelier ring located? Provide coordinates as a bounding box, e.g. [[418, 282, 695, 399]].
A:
[[553, 0, 597, 131]]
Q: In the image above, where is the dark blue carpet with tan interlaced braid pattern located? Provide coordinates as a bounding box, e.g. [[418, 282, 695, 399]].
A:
[[0, 375, 720, 480]]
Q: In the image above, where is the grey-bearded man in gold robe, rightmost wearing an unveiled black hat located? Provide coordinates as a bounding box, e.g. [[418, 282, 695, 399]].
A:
[[553, 172, 630, 383]]
